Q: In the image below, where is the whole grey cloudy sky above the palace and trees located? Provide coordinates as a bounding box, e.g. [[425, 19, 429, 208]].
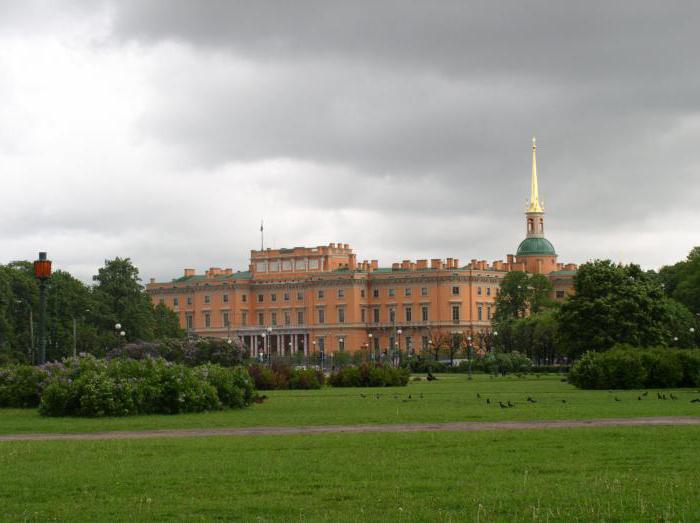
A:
[[0, 0, 700, 280]]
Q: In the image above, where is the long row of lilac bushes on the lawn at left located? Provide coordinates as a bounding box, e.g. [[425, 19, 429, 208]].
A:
[[0, 356, 255, 417]]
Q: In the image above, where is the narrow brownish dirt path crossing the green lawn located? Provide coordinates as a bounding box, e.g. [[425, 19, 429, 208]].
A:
[[0, 416, 700, 442]]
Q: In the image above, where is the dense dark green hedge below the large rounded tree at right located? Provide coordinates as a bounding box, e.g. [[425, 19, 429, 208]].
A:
[[568, 346, 700, 389]]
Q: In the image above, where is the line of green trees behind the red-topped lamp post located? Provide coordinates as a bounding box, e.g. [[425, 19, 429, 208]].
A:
[[0, 257, 183, 364]]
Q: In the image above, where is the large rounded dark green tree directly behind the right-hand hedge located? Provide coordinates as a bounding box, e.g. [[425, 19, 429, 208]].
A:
[[558, 260, 693, 357]]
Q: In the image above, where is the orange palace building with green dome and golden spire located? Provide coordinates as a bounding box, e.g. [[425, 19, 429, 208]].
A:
[[147, 139, 576, 357]]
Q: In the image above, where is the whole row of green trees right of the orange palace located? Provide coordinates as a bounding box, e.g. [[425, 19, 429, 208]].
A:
[[493, 247, 700, 364]]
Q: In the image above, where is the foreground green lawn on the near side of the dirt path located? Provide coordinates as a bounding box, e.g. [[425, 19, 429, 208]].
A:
[[0, 428, 700, 522]]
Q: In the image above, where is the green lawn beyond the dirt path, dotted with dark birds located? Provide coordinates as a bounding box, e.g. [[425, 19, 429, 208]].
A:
[[0, 374, 700, 434]]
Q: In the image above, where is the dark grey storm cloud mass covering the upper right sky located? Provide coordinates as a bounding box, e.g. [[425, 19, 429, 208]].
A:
[[100, 0, 700, 227]]
